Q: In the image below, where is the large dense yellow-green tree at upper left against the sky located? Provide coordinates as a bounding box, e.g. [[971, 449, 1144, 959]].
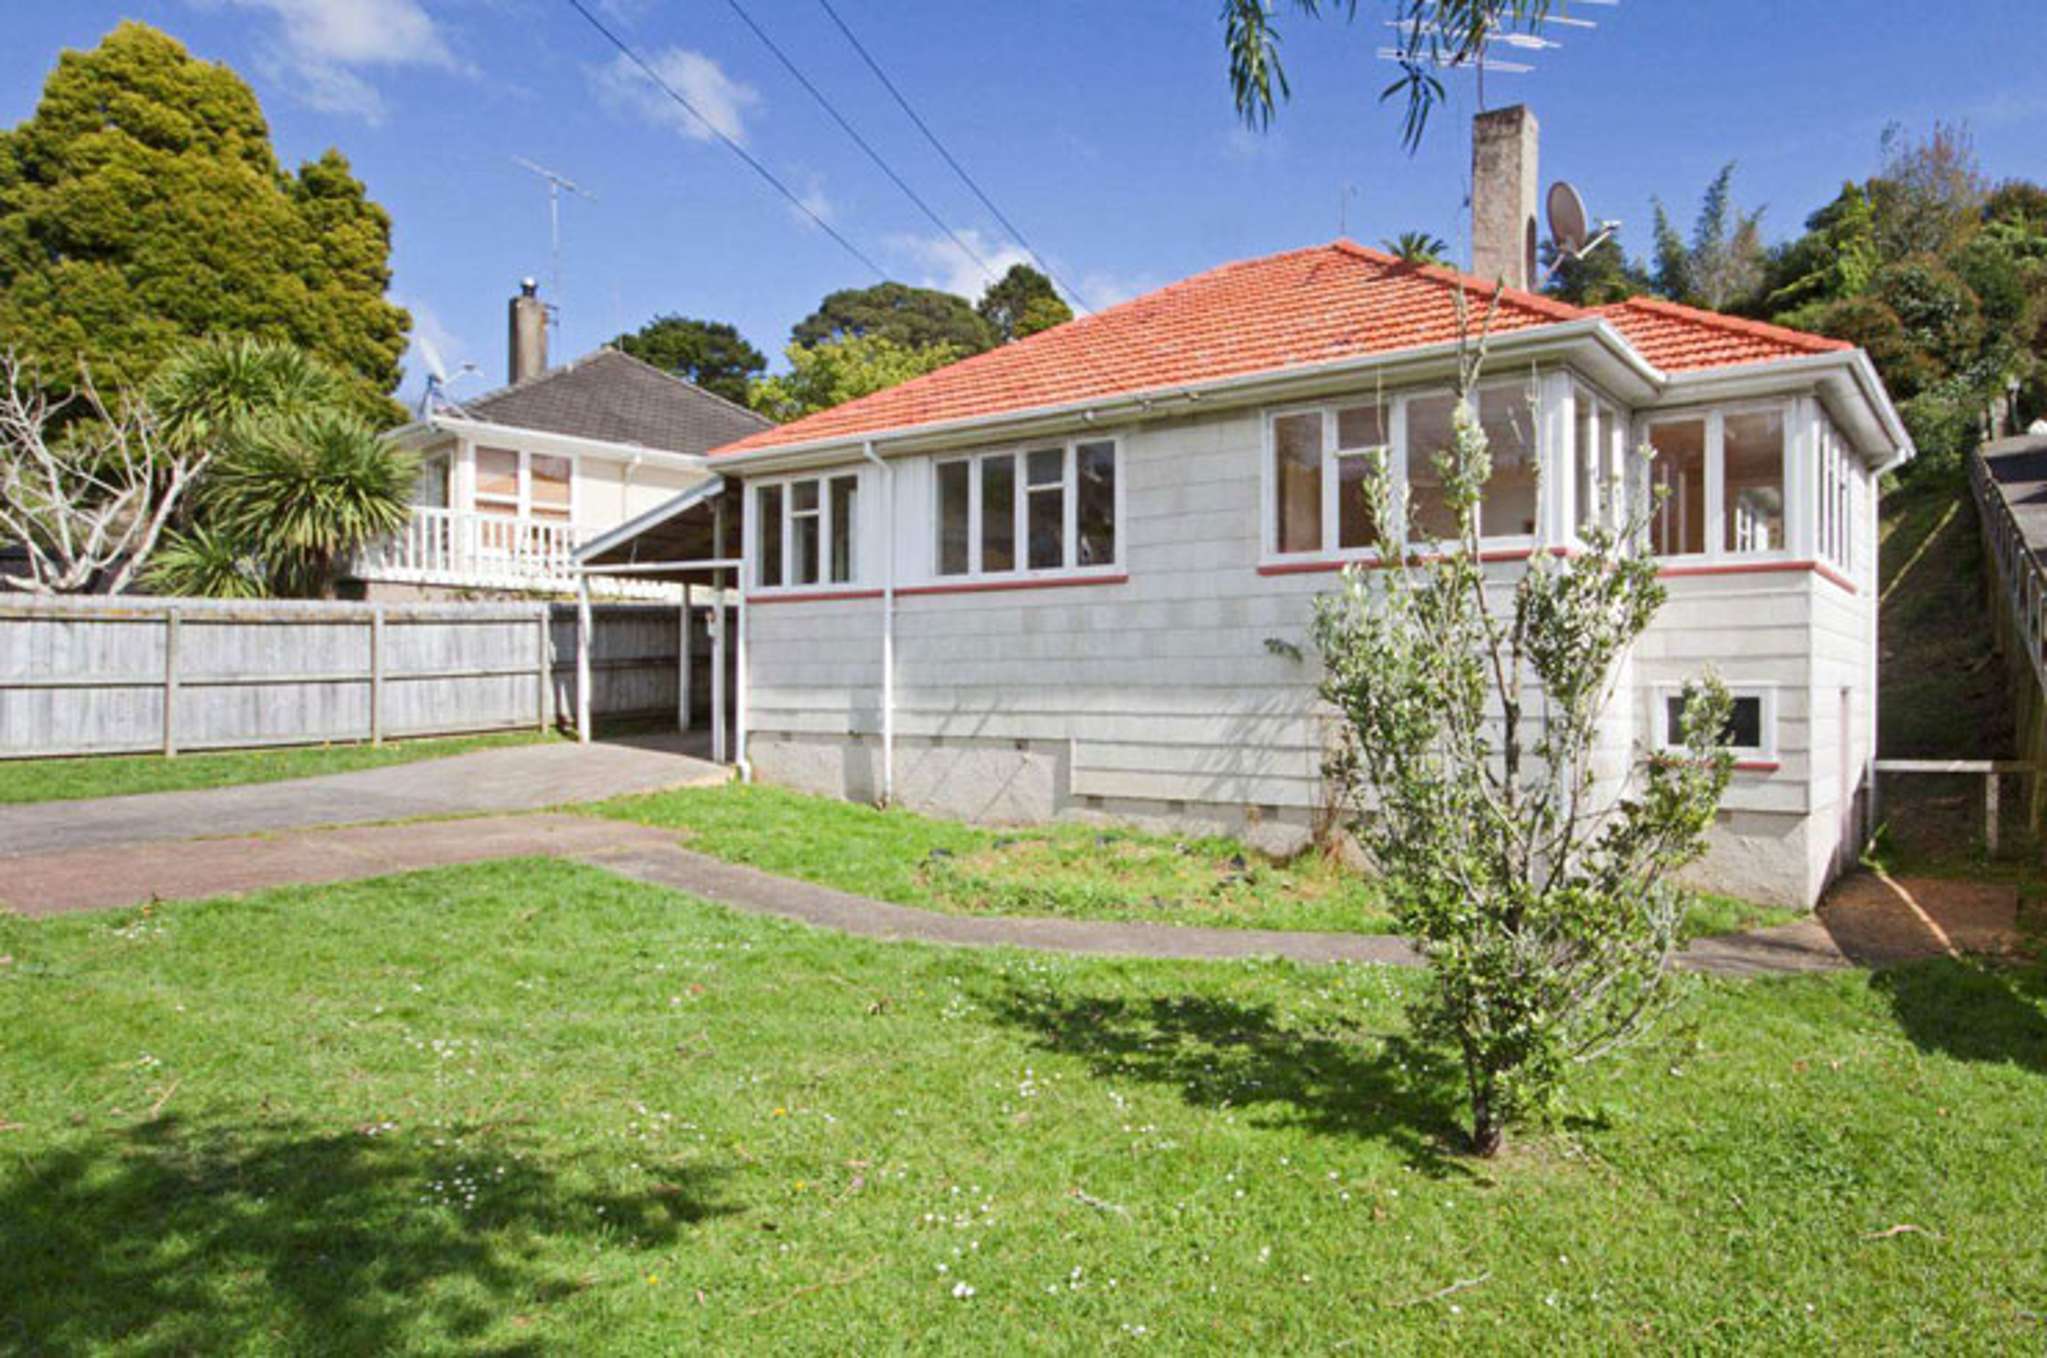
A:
[[0, 23, 411, 420]]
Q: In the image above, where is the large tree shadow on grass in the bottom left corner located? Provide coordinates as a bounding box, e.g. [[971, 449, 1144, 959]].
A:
[[0, 1116, 733, 1354]]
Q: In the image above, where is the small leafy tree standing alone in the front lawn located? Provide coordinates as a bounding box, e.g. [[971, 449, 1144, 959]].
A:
[[1314, 303, 1732, 1155]]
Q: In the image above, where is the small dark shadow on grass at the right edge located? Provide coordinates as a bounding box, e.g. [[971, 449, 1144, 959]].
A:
[[1871, 959, 2047, 1073]]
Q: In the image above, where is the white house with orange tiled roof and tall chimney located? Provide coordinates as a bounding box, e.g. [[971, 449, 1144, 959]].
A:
[[585, 109, 1912, 905]]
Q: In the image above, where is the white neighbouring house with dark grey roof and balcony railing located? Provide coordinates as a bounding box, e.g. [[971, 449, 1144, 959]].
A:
[[350, 283, 772, 600]]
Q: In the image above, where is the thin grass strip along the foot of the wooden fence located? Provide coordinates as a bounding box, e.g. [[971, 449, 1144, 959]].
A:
[[0, 731, 557, 805]]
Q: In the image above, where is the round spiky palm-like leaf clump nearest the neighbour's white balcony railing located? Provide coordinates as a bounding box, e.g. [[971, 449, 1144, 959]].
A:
[[199, 408, 418, 594]]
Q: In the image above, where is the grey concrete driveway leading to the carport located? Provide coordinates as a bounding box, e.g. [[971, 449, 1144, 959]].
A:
[[0, 735, 727, 860]]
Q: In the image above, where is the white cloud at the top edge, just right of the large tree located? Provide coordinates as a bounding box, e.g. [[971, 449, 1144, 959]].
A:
[[199, 0, 467, 123]]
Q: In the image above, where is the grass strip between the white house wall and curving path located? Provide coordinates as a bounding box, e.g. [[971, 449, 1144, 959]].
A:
[[596, 782, 1801, 936]]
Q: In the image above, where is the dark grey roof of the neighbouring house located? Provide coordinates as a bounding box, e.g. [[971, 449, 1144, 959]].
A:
[[456, 348, 774, 453]]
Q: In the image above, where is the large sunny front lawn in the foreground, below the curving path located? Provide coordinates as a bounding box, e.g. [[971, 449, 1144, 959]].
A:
[[0, 862, 2047, 1358]]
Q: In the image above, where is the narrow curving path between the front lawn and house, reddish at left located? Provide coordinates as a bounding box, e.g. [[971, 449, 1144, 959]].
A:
[[12, 813, 2016, 977]]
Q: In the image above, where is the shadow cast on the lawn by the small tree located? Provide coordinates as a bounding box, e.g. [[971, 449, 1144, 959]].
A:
[[991, 989, 1468, 1176]]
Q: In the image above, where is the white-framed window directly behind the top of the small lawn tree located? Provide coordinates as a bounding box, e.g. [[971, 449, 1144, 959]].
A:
[[1259, 373, 1558, 565]]
